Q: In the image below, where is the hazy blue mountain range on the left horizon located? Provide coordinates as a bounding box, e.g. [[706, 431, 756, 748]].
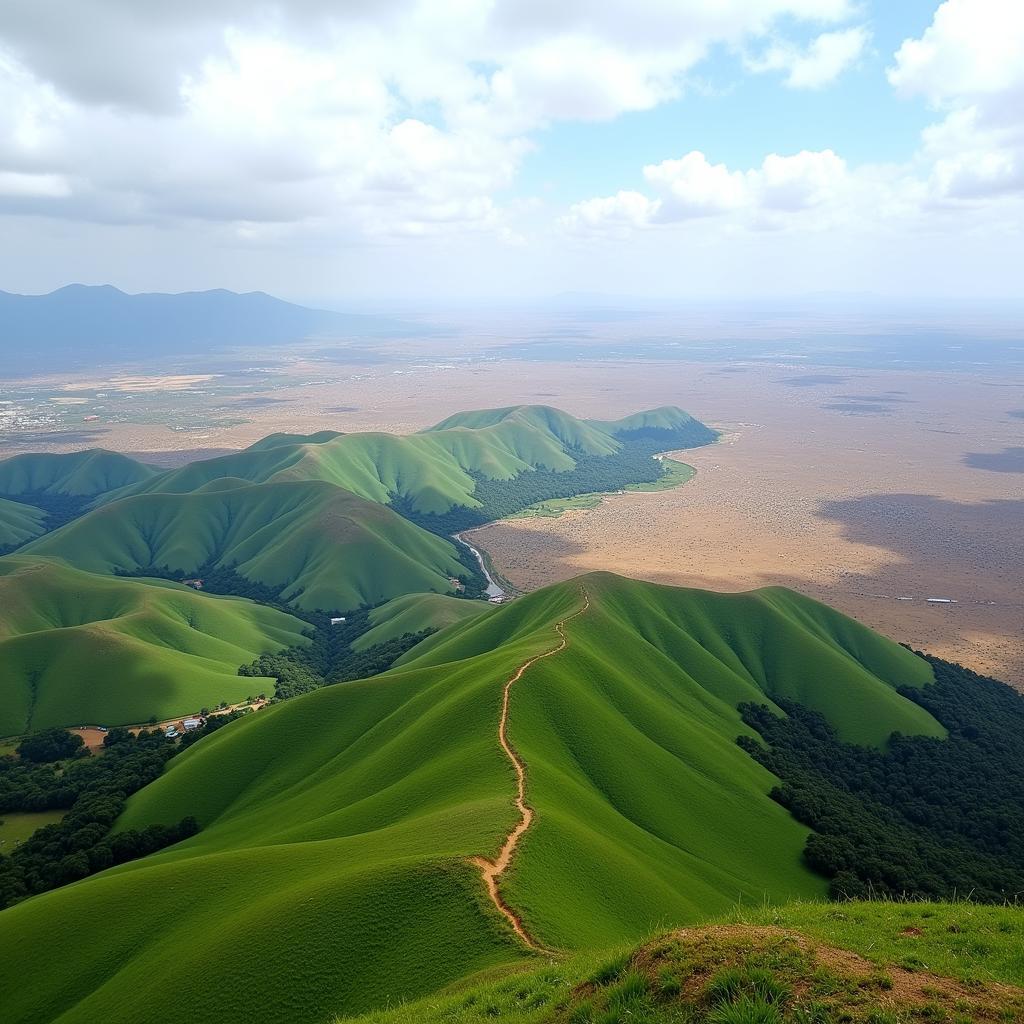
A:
[[0, 285, 410, 370]]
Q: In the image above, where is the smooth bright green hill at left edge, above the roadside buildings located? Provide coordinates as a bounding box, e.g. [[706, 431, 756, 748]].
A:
[[0, 555, 304, 735]]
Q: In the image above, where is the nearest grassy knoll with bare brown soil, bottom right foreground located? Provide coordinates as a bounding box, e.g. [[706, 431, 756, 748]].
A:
[[337, 902, 1024, 1024]]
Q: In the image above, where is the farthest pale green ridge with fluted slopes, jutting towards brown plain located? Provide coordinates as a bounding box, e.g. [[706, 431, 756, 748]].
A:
[[97, 406, 704, 513]]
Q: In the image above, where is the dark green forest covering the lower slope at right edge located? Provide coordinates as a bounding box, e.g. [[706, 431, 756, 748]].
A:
[[739, 655, 1024, 902]]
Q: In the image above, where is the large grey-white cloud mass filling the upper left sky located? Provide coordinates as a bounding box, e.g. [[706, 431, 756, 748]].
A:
[[0, 0, 854, 239]]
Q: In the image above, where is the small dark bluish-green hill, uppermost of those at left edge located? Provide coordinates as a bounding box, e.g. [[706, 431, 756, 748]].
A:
[[0, 449, 158, 497]]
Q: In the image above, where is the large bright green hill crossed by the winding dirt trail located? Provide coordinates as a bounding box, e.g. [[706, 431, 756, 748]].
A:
[[0, 574, 941, 1024]]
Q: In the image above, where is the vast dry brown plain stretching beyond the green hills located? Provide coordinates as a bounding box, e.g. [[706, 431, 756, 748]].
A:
[[2, 359, 1024, 686]]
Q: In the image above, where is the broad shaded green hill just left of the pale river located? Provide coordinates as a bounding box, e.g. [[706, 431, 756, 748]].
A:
[[27, 478, 466, 609]]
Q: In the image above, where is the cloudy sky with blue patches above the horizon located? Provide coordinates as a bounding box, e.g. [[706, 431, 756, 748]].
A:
[[0, 0, 1024, 308]]
